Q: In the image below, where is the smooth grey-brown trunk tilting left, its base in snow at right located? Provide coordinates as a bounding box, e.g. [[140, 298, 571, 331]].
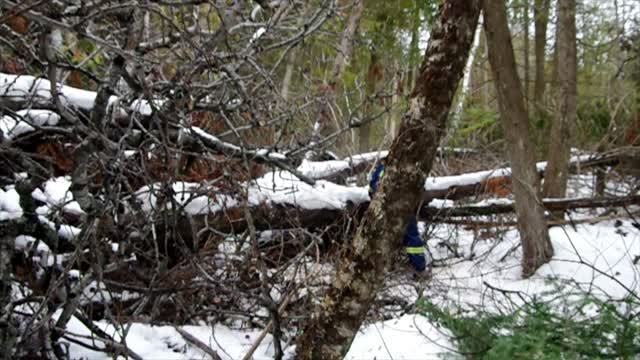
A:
[[483, 0, 553, 277]]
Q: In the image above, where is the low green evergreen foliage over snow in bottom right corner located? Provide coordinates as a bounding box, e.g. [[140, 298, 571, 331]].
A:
[[418, 296, 640, 359]]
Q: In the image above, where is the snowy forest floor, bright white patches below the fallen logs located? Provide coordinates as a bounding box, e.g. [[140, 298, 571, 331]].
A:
[[46, 174, 640, 359]]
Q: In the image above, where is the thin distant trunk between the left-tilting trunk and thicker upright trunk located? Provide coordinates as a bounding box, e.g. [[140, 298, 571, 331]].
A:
[[533, 0, 550, 113]]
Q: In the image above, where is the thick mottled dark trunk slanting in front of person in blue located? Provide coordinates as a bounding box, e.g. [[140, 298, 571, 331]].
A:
[[297, 0, 480, 359]]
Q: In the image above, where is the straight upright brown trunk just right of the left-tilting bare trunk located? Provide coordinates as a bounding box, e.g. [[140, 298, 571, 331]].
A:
[[544, 0, 577, 210]]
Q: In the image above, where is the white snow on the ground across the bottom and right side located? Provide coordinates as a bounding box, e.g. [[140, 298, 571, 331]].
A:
[[52, 210, 640, 360]]
